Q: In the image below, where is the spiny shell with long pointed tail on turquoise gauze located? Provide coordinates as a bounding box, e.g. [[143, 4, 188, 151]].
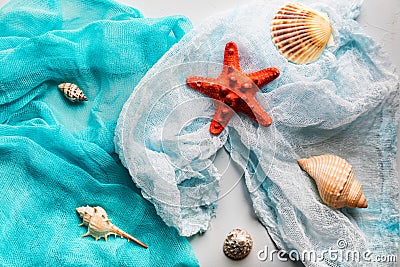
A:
[[76, 206, 148, 248]]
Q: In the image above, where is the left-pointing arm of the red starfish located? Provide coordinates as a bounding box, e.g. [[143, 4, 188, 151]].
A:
[[186, 76, 221, 100]]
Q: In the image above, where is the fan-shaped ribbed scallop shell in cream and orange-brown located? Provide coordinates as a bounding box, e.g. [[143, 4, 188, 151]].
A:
[[271, 3, 333, 64]]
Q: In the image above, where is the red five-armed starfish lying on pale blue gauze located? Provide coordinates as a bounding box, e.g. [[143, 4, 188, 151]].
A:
[[186, 42, 279, 135]]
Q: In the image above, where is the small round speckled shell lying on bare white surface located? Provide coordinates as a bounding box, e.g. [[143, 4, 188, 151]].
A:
[[223, 228, 253, 260]]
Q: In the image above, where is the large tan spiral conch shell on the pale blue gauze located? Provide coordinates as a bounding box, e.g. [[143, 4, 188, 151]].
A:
[[298, 155, 368, 209]]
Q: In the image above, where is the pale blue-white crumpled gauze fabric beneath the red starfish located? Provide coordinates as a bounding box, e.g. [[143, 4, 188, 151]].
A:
[[115, 0, 399, 266]]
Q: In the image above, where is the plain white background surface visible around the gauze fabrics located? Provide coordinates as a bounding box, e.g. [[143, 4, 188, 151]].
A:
[[0, 0, 400, 267]]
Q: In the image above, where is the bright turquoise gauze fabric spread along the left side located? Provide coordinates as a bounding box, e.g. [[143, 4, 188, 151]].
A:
[[0, 0, 198, 266]]
